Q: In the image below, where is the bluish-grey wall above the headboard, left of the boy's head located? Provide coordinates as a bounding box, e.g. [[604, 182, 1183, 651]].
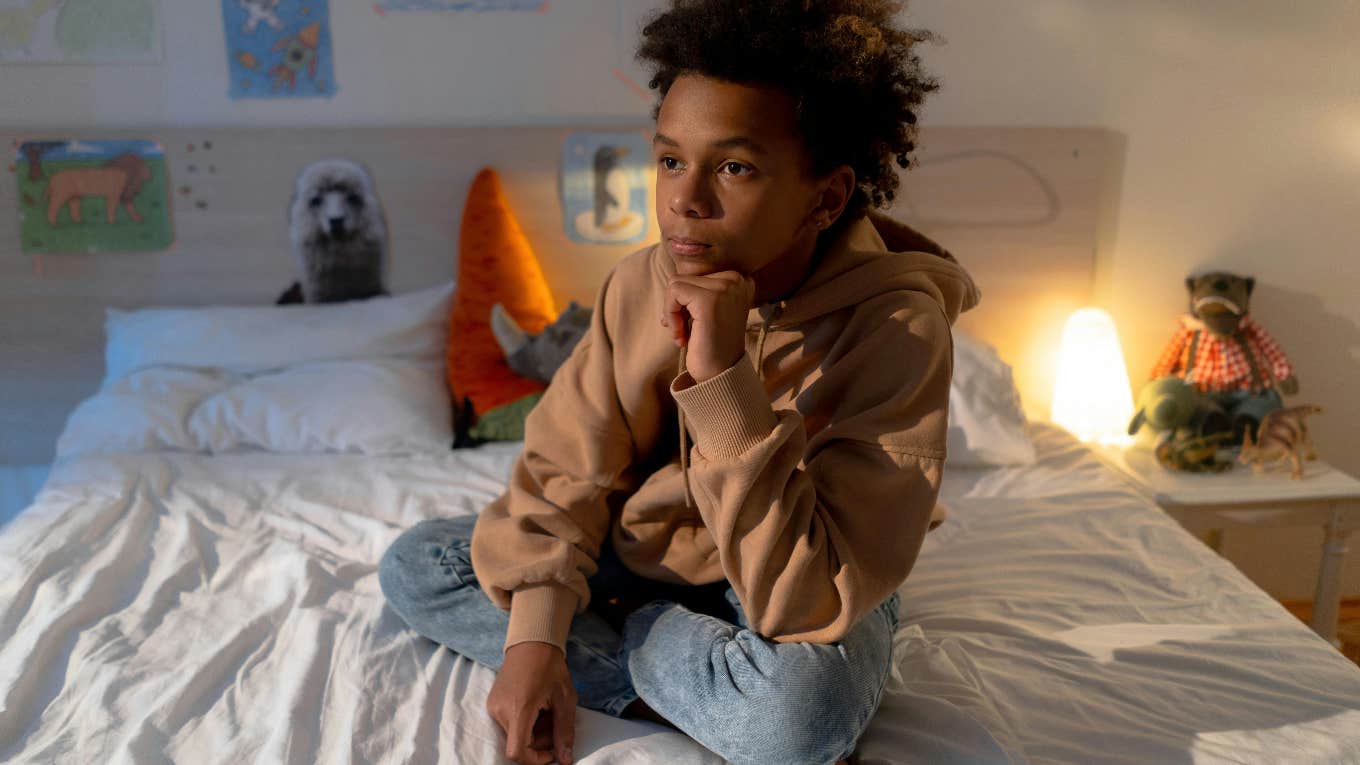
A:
[[0, 0, 649, 127]]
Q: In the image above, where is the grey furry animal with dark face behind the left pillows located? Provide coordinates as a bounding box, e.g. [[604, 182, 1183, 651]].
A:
[[277, 159, 388, 305]]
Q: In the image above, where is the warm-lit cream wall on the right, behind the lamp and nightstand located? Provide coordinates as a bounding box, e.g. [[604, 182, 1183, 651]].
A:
[[908, 0, 1360, 598]]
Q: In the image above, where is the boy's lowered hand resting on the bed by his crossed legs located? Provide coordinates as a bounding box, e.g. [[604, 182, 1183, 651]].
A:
[[487, 641, 577, 765]]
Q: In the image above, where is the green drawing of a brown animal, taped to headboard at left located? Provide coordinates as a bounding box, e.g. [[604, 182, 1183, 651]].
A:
[[15, 140, 174, 253]]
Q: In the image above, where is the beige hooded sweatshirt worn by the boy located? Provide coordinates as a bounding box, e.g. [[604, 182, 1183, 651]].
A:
[[472, 214, 978, 648]]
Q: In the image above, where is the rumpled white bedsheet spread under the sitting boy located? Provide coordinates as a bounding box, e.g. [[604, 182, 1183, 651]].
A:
[[0, 429, 1360, 765]]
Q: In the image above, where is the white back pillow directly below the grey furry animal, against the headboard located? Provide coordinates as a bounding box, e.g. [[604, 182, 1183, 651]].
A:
[[105, 282, 454, 384]]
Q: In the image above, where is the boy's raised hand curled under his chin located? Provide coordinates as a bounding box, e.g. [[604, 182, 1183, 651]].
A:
[[661, 271, 756, 383]]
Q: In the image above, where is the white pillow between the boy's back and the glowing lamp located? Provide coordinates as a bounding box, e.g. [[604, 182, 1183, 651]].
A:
[[945, 329, 1035, 467]]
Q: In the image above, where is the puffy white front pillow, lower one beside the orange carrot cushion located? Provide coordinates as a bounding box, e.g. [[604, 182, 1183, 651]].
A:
[[188, 359, 453, 455]]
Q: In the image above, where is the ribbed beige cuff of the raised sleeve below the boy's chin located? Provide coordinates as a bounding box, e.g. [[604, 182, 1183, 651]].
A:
[[670, 355, 779, 459]]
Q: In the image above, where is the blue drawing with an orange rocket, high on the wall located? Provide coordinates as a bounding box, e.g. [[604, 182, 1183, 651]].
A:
[[222, 0, 336, 98]]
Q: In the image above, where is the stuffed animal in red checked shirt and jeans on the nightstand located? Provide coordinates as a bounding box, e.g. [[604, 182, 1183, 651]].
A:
[[1149, 271, 1299, 441]]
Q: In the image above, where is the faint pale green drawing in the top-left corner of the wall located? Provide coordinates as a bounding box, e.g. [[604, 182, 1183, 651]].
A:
[[0, 0, 160, 64]]
